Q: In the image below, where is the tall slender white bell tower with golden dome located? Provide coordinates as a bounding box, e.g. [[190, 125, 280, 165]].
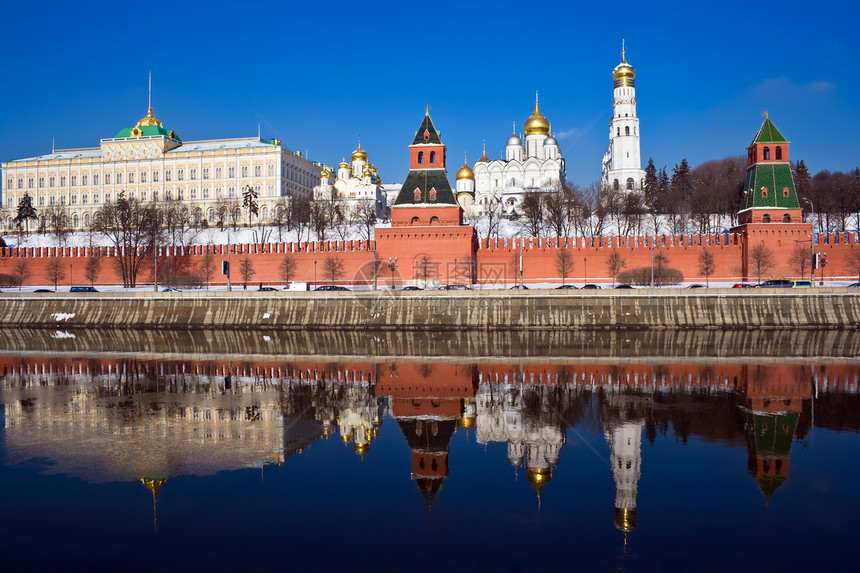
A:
[[602, 40, 645, 191]]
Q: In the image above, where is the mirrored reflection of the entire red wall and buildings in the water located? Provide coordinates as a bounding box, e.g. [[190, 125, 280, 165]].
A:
[[0, 348, 860, 533]]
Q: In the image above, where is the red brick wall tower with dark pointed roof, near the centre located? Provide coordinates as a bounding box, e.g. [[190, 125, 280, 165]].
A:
[[375, 106, 477, 288]]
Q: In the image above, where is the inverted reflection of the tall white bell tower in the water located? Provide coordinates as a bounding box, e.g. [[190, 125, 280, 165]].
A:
[[603, 394, 647, 544]]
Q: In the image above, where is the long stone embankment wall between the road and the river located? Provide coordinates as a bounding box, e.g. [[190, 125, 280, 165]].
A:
[[0, 288, 860, 330]]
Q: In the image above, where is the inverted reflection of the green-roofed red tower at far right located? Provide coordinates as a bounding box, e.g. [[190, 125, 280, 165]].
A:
[[741, 365, 812, 503]]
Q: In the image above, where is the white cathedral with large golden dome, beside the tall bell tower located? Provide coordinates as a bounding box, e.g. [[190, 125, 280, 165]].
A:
[[464, 97, 564, 216]]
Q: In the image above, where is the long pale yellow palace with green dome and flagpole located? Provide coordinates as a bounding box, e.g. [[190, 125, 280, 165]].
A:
[[2, 107, 320, 230]]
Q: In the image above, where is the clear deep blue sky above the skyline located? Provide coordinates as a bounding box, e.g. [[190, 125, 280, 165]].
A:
[[0, 0, 860, 184]]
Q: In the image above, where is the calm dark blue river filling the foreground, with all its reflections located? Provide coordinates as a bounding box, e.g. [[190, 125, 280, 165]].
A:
[[0, 329, 860, 571]]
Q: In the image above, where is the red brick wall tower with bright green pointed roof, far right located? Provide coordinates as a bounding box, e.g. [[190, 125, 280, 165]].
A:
[[731, 112, 812, 280]]
